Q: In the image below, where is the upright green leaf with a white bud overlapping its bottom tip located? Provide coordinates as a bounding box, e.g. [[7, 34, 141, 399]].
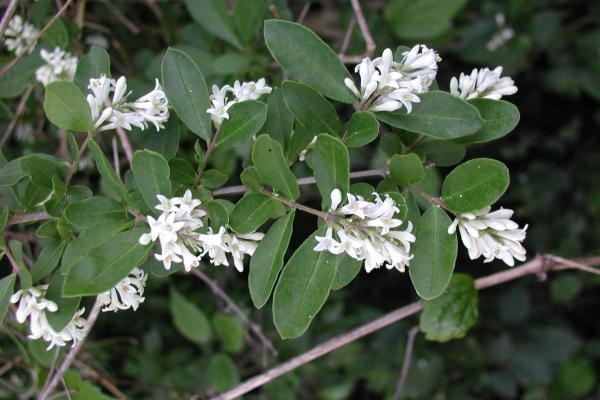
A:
[[311, 134, 350, 209]]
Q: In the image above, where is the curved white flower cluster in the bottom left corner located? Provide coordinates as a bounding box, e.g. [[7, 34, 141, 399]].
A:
[[10, 285, 87, 350]]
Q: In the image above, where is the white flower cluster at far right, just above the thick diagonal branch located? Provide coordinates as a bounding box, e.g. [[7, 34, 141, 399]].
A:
[[448, 207, 527, 267]]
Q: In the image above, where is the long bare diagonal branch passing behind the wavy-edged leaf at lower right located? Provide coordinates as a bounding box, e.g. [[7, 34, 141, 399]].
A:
[[214, 256, 600, 400]]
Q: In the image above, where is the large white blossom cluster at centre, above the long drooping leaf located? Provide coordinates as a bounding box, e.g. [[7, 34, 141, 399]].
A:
[[314, 189, 415, 272]]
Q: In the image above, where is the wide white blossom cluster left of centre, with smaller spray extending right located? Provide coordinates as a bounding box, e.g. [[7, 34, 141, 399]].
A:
[[140, 190, 264, 272]]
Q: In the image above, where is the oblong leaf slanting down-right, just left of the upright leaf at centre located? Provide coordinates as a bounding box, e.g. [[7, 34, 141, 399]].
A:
[[252, 135, 300, 200]]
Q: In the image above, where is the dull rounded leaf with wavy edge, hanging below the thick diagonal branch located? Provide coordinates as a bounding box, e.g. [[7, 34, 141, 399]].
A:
[[419, 274, 479, 342]]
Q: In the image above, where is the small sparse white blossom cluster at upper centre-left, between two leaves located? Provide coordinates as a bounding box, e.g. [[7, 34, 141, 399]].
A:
[[206, 78, 271, 128]]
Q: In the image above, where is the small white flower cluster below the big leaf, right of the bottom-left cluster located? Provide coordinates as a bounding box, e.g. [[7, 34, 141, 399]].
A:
[[98, 268, 148, 312]]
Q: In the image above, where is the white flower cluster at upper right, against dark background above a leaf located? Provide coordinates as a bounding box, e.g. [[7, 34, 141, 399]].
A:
[[450, 67, 517, 100]]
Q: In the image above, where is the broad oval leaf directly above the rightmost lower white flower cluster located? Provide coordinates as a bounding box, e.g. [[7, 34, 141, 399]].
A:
[[442, 158, 510, 213]]
